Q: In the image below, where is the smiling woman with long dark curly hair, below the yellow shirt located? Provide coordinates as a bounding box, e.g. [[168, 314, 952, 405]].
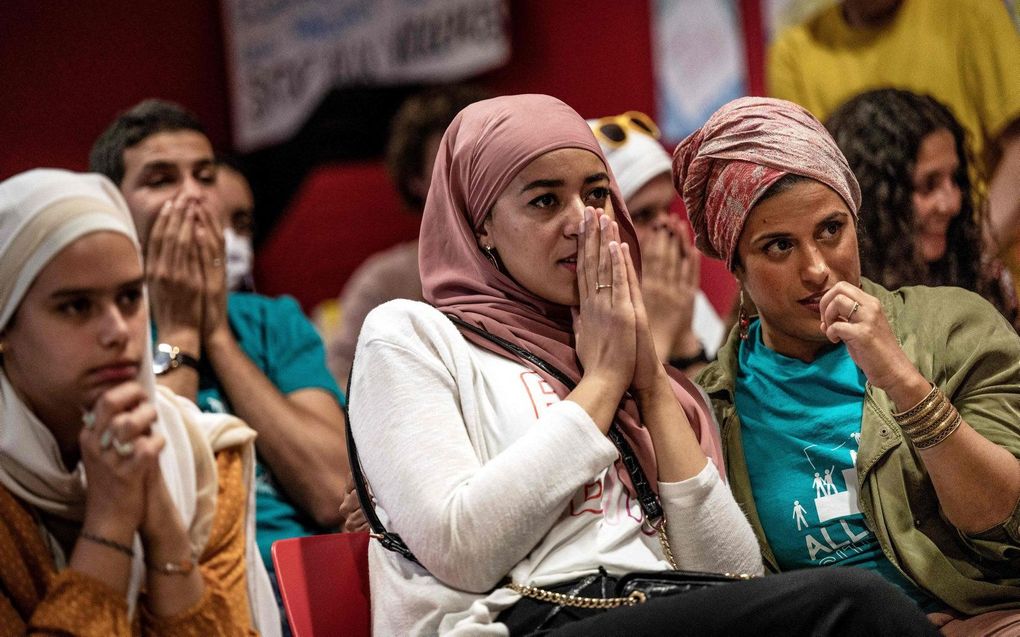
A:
[[826, 89, 1020, 326]]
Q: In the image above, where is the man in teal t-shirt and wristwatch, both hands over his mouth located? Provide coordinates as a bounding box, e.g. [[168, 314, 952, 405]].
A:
[[90, 100, 347, 607]]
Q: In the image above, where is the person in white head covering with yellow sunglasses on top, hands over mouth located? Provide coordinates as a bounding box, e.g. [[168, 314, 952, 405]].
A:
[[588, 111, 724, 375]]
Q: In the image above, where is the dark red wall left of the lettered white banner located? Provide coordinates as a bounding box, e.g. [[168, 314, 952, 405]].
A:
[[0, 0, 228, 178]]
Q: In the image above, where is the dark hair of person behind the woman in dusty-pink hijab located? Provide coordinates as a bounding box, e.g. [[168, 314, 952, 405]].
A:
[[386, 85, 489, 212]]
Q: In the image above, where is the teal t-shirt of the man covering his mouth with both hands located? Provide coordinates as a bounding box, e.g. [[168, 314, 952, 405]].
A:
[[153, 293, 344, 574]]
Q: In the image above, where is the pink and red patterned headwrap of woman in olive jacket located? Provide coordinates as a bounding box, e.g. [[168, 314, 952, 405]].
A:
[[673, 97, 861, 270]]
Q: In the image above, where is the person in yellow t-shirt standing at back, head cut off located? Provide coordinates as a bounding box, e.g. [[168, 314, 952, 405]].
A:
[[766, 0, 1020, 291]]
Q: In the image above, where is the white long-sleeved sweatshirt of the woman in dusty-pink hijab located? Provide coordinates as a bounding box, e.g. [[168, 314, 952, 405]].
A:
[[350, 301, 762, 635]]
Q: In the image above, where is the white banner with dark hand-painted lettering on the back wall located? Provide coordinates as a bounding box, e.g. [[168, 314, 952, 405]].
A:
[[222, 0, 510, 151]]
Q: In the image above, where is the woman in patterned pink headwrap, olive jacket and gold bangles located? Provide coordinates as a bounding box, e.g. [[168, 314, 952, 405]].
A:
[[673, 98, 1020, 634]]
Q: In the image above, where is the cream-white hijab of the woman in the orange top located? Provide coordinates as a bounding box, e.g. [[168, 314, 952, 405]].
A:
[[0, 168, 279, 635]]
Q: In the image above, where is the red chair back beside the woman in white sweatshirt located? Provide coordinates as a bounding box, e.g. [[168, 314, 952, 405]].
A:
[[272, 533, 371, 637]]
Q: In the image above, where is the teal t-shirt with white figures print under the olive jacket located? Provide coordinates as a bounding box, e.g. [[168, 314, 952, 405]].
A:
[[735, 320, 939, 609]]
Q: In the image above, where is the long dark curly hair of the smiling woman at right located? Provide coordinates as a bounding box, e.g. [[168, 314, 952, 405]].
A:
[[825, 89, 1007, 314]]
